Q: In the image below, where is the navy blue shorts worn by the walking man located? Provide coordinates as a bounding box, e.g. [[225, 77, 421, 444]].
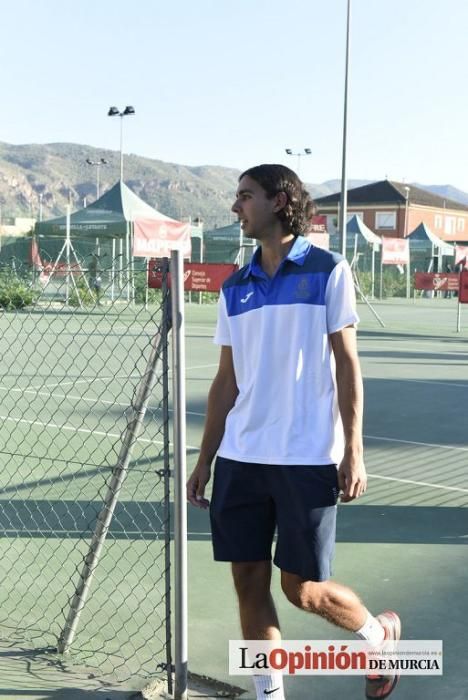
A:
[[210, 457, 339, 581]]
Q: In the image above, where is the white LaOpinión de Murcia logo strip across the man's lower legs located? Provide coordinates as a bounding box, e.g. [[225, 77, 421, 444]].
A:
[[229, 639, 443, 676]]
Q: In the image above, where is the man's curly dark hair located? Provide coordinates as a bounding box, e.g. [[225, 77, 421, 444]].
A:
[[239, 163, 315, 235]]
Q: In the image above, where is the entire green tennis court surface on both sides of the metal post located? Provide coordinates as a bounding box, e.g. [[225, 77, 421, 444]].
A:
[[0, 299, 468, 700]]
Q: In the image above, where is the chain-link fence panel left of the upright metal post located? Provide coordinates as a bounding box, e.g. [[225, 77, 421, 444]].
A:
[[0, 254, 171, 682]]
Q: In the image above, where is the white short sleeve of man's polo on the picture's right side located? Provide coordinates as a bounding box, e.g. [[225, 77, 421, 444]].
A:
[[325, 260, 359, 334]]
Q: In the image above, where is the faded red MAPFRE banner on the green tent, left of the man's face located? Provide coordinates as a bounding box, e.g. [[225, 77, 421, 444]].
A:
[[133, 214, 192, 258]]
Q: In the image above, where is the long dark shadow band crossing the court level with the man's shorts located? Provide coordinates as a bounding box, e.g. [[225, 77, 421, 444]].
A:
[[0, 500, 468, 545]]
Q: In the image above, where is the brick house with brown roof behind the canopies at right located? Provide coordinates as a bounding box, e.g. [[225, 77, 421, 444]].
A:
[[315, 180, 468, 243]]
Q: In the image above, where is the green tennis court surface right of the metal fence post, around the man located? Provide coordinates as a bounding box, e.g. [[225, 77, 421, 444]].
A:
[[183, 299, 468, 700]]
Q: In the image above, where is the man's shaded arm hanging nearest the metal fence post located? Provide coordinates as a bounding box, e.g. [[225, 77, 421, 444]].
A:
[[187, 345, 239, 508]]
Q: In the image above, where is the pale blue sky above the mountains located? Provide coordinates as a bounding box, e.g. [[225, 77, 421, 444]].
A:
[[0, 0, 468, 191]]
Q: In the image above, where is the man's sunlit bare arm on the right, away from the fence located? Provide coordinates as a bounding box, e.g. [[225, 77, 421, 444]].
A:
[[330, 326, 367, 503]]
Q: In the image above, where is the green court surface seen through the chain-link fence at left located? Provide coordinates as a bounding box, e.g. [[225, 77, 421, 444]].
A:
[[0, 307, 170, 697]]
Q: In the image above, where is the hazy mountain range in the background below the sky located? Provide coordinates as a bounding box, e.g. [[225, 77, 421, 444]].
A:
[[0, 142, 468, 228]]
